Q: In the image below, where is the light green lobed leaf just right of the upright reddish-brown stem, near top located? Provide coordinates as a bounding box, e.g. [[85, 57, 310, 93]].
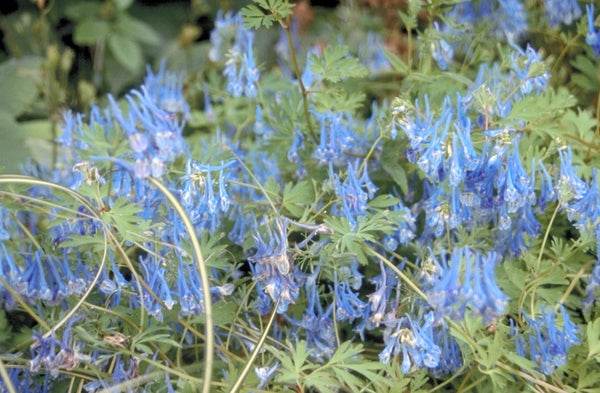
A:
[[310, 45, 369, 83]]
